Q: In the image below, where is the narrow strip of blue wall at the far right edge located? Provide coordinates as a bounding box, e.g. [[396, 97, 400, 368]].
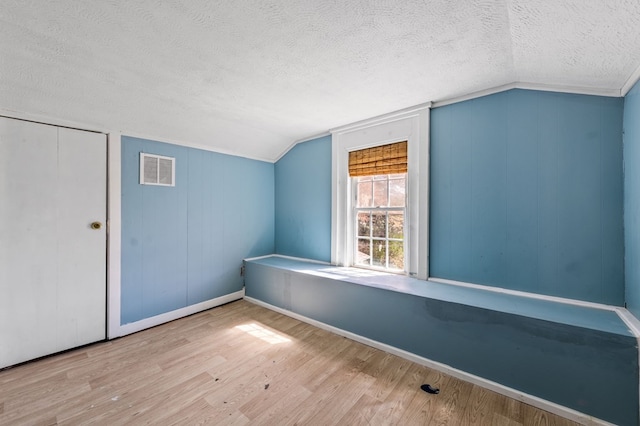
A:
[[624, 82, 640, 318]]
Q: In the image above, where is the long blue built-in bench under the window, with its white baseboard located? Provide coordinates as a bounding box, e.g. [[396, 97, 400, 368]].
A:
[[245, 255, 639, 425]]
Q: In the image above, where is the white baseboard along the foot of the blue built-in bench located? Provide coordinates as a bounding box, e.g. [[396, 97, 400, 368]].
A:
[[244, 296, 612, 425]]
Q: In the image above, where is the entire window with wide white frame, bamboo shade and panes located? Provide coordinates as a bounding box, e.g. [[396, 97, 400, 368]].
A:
[[331, 104, 430, 279]]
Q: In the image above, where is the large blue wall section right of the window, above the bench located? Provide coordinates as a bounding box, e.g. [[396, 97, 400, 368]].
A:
[[429, 90, 624, 305]]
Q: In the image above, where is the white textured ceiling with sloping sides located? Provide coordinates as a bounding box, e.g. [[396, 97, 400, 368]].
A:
[[0, 0, 640, 161]]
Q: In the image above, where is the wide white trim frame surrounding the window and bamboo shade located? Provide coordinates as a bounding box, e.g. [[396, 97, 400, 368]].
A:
[[331, 103, 431, 280]]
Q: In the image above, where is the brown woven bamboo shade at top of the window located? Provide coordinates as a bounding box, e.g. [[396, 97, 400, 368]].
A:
[[349, 141, 407, 177]]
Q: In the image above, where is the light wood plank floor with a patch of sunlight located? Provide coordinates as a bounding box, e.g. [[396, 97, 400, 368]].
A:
[[0, 301, 574, 425]]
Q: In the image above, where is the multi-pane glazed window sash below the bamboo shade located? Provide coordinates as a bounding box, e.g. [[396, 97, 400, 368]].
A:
[[352, 173, 407, 272]]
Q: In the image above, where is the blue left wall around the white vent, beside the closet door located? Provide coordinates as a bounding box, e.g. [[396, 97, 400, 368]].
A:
[[121, 136, 274, 324]]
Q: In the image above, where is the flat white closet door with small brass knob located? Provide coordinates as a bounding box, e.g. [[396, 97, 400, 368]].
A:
[[0, 117, 107, 368]]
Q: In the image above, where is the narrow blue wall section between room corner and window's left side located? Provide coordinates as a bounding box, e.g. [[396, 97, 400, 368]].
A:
[[275, 136, 331, 262]]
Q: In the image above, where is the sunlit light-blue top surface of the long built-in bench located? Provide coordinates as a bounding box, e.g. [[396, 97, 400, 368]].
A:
[[247, 256, 634, 337]]
